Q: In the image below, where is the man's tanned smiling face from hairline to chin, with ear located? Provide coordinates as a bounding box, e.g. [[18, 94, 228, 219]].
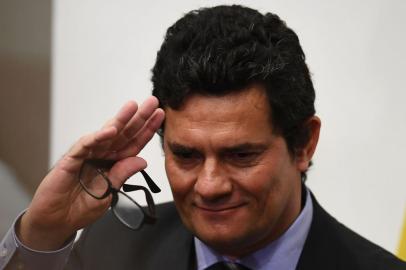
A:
[[164, 86, 320, 258]]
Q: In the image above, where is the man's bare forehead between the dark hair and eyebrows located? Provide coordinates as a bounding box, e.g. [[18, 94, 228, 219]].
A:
[[164, 86, 272, 144]]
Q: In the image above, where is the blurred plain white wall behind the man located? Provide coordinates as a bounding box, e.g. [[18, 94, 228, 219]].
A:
[[51, 0, 406, 252]]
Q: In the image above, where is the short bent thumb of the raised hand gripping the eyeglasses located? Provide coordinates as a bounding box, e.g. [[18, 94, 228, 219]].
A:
[[109, 157, 147, 189]]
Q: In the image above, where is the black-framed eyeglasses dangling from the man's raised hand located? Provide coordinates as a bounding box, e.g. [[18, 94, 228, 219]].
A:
[[79, 159, 161, 230]]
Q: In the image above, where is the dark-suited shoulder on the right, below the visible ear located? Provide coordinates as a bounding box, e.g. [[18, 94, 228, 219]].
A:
[[298, 194, 406, 270]]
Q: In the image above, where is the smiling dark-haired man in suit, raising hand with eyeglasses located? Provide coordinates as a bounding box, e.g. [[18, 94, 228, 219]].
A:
[[3, 6, 406, 270]]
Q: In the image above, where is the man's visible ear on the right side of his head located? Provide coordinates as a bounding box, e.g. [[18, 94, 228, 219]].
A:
[[296, 116, 321, 172]]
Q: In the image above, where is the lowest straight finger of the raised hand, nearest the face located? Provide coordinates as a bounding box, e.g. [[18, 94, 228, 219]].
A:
[[115, 109, 165, 159]]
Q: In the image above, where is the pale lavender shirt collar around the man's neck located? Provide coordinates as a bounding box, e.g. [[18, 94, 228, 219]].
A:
[[194, 188, 313, 270]]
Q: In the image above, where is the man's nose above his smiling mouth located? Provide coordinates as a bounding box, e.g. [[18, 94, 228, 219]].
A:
[[194, 158, 233, 201]]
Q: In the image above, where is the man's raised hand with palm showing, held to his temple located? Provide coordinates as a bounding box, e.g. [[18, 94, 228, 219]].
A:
[[17, 97, 164, 250]]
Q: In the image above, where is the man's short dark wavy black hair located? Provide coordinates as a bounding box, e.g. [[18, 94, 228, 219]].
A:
[[152, 5, 315, 178]]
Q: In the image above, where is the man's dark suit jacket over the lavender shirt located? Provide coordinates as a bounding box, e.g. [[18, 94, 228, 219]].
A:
[[67, 197, 406, 270]]
